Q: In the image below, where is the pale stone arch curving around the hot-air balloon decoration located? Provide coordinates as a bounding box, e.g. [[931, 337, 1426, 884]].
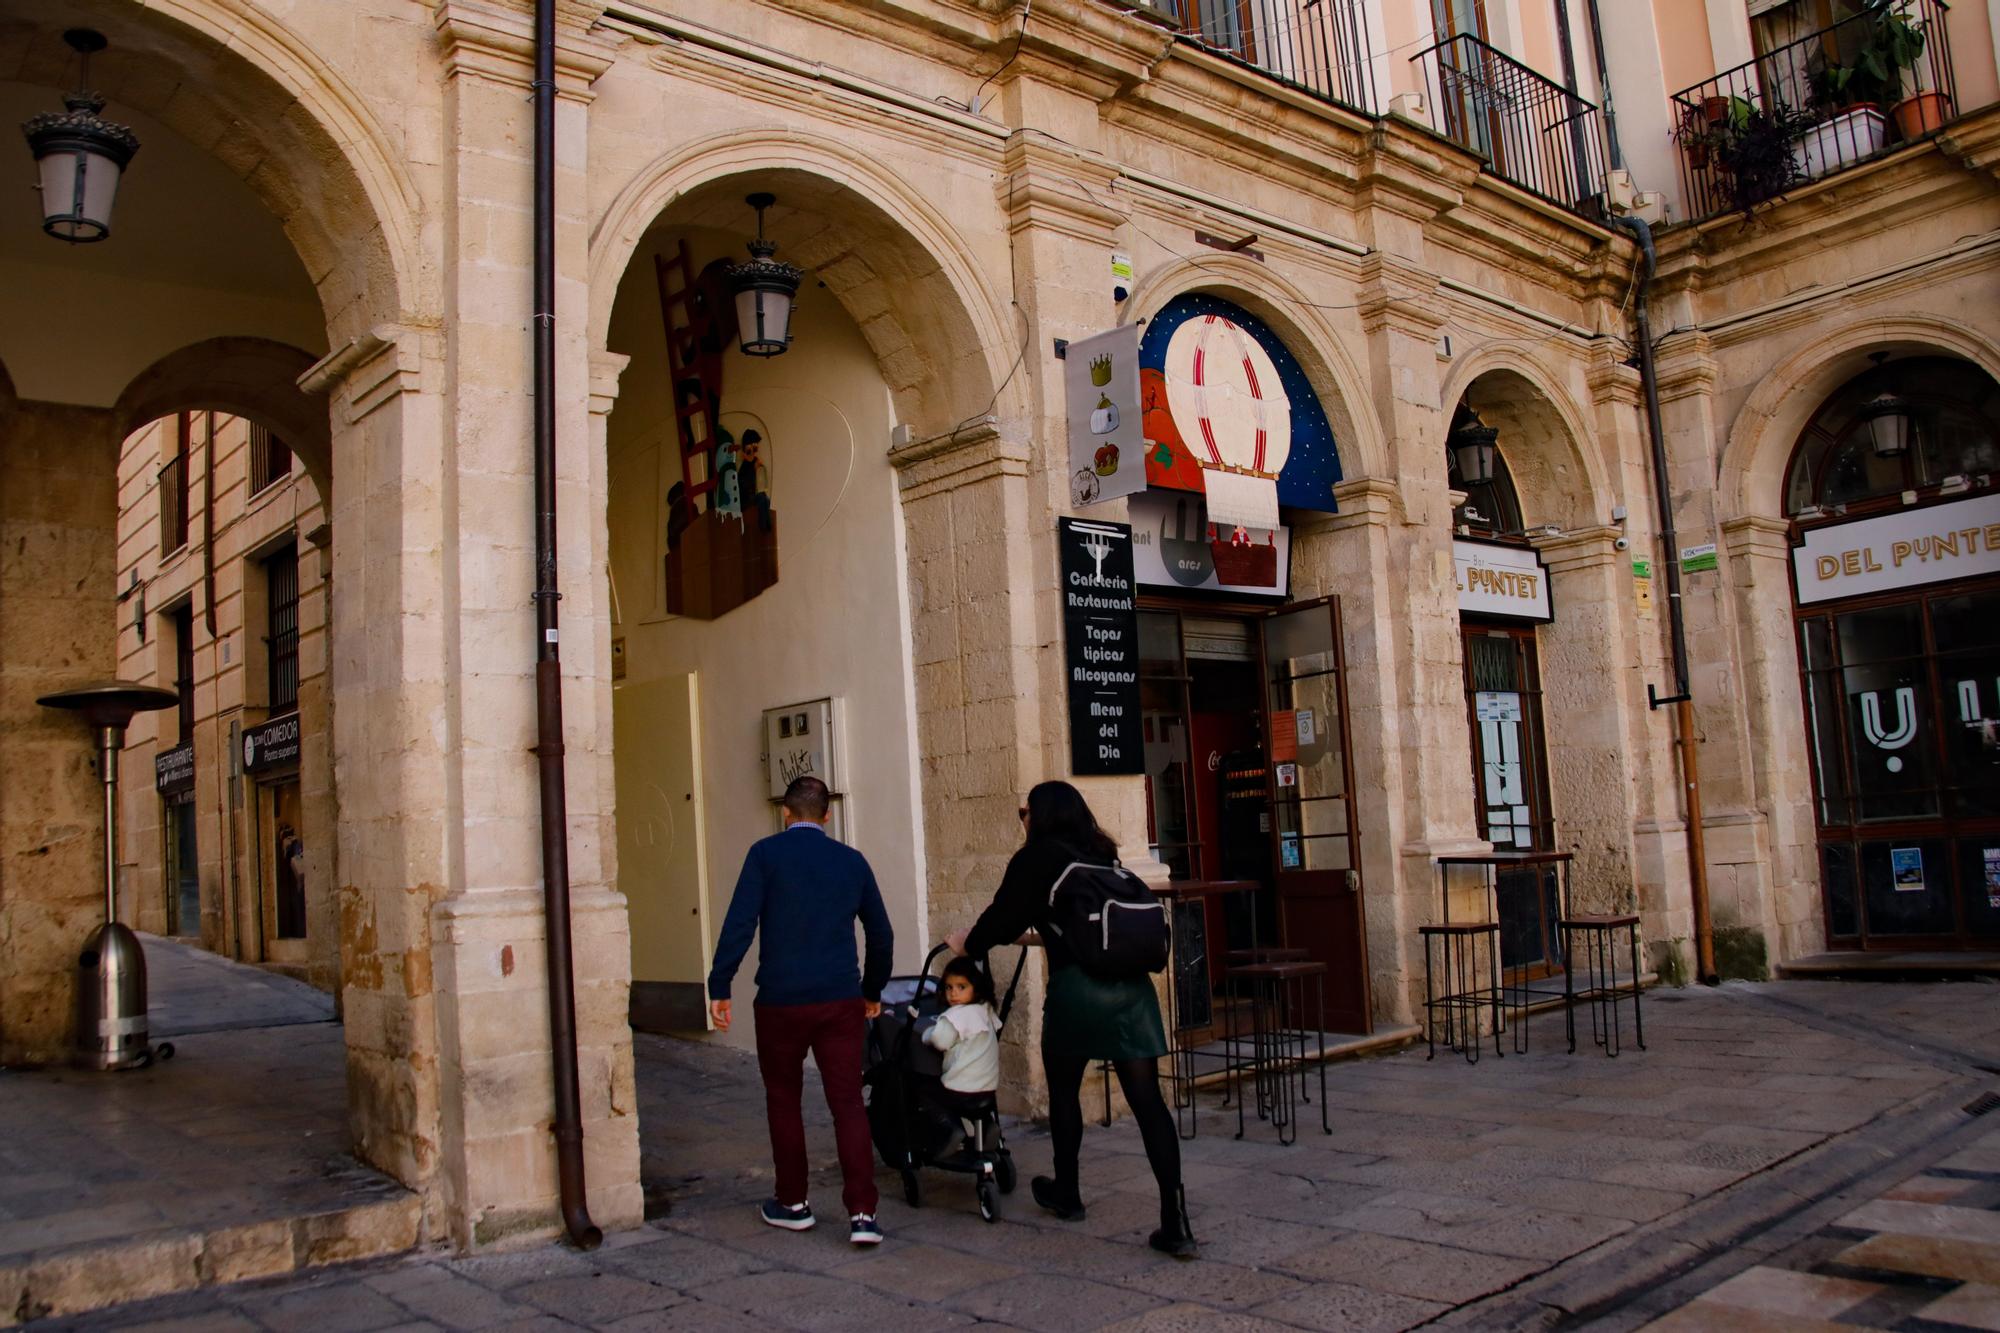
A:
[[1126, 254, 1390, 480]]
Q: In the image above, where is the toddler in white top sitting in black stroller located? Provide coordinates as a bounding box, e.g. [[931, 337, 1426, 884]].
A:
[[862, 932, 1026, 1221]]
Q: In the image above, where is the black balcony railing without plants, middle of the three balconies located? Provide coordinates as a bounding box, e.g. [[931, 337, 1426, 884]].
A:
[[1412, 34, 1604, 218]]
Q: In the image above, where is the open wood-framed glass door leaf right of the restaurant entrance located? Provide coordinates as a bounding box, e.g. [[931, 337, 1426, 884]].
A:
[[1262, 596, 1372, 1033]]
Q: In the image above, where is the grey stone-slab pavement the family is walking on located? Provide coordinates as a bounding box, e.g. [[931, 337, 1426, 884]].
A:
[[39, 983, 2000, 1331]]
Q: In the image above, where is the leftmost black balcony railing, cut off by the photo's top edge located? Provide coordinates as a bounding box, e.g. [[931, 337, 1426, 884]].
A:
[[1138, 0, 1380, 116]]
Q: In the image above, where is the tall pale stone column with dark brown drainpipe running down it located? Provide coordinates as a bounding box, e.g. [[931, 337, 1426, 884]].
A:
[[426, 0, 640, 1247]]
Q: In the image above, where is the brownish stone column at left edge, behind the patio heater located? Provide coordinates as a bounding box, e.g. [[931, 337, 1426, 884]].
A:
[[0, 396, 120, 1065]]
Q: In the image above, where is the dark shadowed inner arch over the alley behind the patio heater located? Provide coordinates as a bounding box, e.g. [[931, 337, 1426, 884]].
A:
[[112, 338, 334, 502]]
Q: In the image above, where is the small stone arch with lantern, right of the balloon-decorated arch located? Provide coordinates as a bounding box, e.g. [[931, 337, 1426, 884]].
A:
[[1438, 340, 1610, 530]]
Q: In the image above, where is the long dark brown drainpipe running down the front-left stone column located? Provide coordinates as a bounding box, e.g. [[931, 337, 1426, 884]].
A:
[[534, 0, 604, 1249]]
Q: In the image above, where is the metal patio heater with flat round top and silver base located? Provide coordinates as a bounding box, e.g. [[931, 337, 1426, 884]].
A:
[[36, 681, 180, 1069]]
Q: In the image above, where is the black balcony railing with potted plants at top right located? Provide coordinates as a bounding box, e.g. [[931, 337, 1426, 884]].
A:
[[1672, 0, 1958, 222]]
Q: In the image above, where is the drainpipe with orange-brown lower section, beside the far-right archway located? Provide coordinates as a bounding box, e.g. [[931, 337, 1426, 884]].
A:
[[1592, 215, 1716, 985]]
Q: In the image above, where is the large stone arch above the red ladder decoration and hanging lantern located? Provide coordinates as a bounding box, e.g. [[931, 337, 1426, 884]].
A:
[[590, 128, 1008, 438]]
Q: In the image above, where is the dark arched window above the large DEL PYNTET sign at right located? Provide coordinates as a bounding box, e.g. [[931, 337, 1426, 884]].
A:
[[1784, 356, 2000, 516]]
